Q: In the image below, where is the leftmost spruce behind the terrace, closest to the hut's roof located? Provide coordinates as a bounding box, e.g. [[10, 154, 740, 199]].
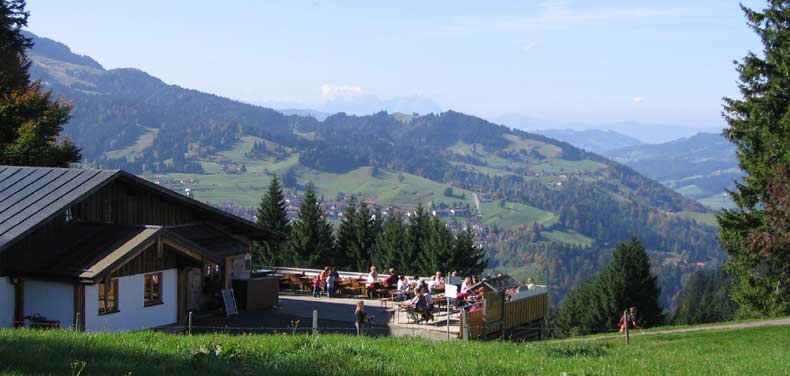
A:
[[255, 175, 291, 266]]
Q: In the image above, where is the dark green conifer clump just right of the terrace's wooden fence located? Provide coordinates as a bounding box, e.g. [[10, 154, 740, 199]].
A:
[[557, 238, 664, 335]]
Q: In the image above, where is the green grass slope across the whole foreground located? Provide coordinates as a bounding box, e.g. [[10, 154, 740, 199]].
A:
[[0, 327, 790, 376]]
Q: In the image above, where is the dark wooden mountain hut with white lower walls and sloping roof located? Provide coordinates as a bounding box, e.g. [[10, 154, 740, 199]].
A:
[[0, 166, 278, 331]]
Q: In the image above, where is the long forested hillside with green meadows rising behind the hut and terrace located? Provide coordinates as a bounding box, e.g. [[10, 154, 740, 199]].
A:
[[29, 32, 721, 306]]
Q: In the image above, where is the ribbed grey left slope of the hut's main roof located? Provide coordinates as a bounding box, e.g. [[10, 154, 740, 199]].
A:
[[0, 166, 118, 250]]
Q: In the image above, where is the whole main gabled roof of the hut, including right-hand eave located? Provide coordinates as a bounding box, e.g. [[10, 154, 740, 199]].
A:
[[0, 166, 281, 252]]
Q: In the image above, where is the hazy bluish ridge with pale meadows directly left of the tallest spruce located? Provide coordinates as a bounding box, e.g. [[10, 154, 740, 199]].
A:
[[603, 133, 743, 208]]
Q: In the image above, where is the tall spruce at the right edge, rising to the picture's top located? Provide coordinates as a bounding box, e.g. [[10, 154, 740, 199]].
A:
[[718, 0, 790, 317]]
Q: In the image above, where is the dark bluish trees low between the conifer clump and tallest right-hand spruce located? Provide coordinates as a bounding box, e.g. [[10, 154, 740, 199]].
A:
[[672, 270, 738, 325]]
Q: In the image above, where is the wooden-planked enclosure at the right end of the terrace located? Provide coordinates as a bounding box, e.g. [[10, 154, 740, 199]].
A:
[[459, 275, 549, 339]]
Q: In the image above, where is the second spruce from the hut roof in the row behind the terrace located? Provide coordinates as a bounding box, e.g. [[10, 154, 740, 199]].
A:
[[285, 187, 334, 268]]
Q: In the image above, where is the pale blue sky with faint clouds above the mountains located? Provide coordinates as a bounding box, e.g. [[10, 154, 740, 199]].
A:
[[28, 0, 764, 128]]
